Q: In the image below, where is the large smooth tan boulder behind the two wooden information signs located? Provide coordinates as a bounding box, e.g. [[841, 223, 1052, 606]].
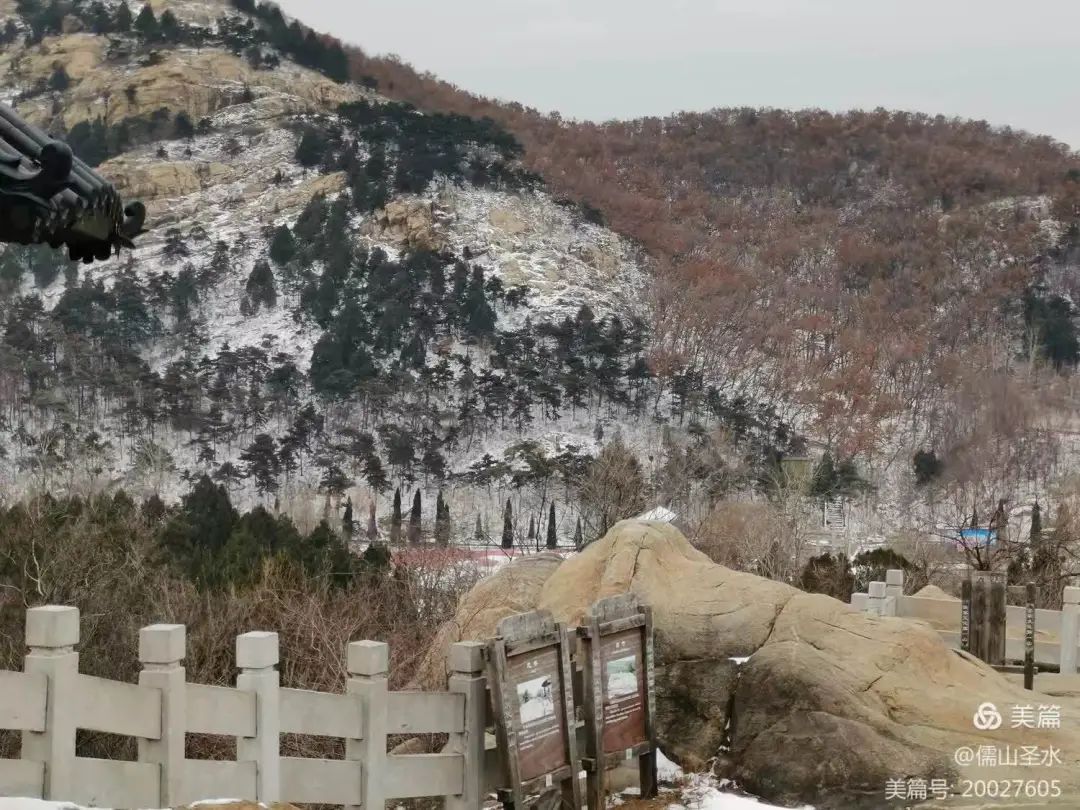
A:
[[427, 521, 1080, 808]]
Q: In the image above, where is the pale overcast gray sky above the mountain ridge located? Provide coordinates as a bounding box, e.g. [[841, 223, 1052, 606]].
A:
[[274, 0, 1080, 148]]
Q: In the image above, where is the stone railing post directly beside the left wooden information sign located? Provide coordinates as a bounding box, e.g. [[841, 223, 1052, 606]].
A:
[[446, 642, 487, 810]]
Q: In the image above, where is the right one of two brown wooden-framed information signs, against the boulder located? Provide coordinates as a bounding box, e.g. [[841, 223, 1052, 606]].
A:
[[578, 594, 657, 810]]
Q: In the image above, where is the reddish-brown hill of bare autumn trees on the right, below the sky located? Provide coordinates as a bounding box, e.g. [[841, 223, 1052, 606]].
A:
[[349, 49, 1080, 527]]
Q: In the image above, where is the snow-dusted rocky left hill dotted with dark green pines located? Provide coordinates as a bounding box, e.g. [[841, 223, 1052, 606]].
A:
[[0, 0, 801, 545]]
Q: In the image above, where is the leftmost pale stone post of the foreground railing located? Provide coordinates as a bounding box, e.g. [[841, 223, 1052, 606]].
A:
[[23, 605, 79, 799]]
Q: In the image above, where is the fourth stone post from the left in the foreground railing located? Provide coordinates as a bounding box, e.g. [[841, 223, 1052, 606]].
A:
[[345, 642, 390, 810]]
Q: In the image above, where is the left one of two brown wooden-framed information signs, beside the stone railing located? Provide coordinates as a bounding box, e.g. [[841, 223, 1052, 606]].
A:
[[488, 610, 581, 810]]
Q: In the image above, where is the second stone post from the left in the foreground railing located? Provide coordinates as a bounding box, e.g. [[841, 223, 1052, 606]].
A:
[[138, 624, 188, 807]]
